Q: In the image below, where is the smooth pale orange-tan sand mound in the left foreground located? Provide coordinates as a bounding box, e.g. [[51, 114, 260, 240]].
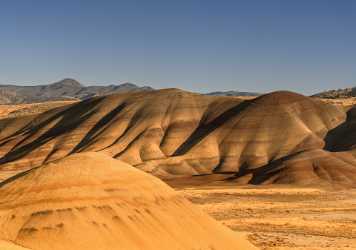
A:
[[0, 152, 255, 250]]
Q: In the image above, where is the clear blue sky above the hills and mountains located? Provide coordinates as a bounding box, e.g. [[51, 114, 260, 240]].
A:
[[0, 0, 356, 94]]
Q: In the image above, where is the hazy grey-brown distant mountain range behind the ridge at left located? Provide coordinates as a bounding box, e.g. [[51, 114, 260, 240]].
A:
[[0, 78, 153, 104]]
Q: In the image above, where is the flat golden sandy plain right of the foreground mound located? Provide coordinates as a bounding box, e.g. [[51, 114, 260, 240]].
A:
[[179, 186, 356, 250]]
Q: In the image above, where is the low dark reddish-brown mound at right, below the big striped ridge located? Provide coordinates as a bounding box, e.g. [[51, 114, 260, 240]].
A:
[[242, 149, 356, 187]]
